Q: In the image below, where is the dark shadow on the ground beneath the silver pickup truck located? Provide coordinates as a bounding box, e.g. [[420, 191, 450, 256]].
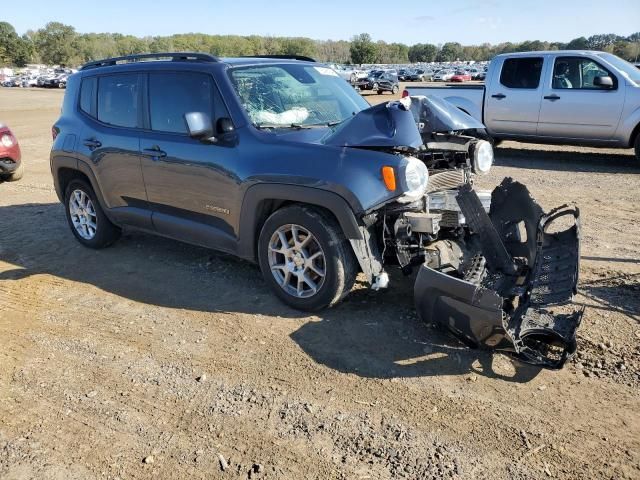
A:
[[495, 146, 640, 174]]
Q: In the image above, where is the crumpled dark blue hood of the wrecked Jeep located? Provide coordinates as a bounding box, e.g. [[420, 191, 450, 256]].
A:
[[320, 96, 485, 149]]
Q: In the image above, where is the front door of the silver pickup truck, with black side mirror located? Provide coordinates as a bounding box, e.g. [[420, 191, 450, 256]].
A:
[[538, 56, 624, 140]]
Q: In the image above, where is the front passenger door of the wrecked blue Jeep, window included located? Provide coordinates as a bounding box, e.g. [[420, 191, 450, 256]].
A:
[[140, 71, 239, 251]]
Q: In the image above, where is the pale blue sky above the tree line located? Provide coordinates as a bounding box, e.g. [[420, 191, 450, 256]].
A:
[[1, 0, 640, 44]]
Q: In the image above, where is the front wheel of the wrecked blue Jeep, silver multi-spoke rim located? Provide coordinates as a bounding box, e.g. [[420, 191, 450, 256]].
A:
[[258, 205, 358, 311]]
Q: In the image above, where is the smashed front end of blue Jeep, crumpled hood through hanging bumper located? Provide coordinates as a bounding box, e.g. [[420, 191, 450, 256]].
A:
[[332, 97, 582, 369]]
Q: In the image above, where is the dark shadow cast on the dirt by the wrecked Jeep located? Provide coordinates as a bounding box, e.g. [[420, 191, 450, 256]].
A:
[[0, 204, 540, 382]]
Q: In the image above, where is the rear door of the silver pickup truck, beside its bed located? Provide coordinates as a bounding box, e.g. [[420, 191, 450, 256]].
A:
[[484, 55, 544, 136]]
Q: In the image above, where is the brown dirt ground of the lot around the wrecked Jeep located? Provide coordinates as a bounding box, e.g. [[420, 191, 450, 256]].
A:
[[0, 84, 640, 480]]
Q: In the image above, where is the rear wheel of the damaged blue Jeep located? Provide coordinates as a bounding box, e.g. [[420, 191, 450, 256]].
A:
[[64, 180, 121, 249]]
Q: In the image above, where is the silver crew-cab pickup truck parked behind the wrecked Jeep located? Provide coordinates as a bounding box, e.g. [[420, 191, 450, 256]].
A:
[[403, 50, 640, 160]]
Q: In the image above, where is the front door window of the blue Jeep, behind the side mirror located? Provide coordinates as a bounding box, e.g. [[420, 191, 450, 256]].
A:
[[149, 72, 214, 134]]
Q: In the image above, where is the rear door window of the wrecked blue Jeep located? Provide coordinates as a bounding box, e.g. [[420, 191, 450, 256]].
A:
[[98, 74, 139, 128]]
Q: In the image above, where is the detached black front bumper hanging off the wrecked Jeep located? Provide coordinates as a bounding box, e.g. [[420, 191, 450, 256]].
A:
[[414, 179, 583, 369]]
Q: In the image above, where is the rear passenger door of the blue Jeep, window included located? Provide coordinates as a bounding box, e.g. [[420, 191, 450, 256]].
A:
[[77, 73, 151, 228]]
